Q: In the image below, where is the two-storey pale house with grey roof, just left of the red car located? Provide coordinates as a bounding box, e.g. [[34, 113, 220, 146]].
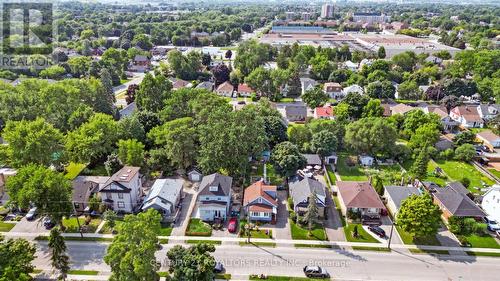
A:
[[197, 173, 233, 221]]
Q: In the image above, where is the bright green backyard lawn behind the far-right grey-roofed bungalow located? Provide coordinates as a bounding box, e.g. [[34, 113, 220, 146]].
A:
[[436, 160, 494, 193]]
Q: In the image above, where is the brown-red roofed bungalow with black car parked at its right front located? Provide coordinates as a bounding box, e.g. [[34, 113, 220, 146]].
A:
[[337, 181, 385, 225]]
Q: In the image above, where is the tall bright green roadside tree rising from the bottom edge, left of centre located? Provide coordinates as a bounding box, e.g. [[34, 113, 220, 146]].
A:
[[104, 209, 161, 281]]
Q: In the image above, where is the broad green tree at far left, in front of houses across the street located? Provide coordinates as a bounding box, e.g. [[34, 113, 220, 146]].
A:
[[6, 165, 73, 225]]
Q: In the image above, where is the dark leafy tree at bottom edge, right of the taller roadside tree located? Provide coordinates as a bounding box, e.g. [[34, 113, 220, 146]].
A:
[[167, 243, 215, 281]]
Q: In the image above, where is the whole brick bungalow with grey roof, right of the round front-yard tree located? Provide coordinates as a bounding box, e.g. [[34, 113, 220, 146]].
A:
[[433, 185, 486, 220]]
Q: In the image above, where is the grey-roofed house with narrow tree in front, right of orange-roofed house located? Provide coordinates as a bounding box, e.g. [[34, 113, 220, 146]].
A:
[[289, 178, 326, 217]]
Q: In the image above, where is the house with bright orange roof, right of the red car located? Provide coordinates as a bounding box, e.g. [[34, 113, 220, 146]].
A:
[[243, 180, 278, 222]]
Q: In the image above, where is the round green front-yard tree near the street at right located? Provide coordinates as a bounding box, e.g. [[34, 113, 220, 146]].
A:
[[396, 194, 441, 237]]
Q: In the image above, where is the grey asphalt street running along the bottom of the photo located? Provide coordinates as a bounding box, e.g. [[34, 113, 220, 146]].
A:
[[34, 242, 500, 281]]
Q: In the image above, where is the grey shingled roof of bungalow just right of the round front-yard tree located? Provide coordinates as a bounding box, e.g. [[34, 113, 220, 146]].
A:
[[434, 187, 486, 217]]
